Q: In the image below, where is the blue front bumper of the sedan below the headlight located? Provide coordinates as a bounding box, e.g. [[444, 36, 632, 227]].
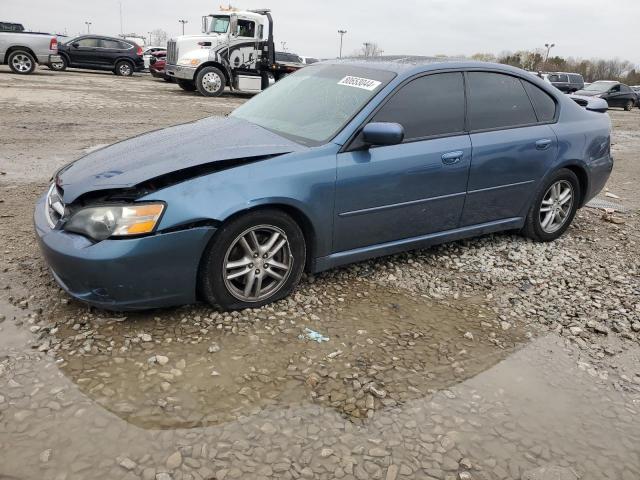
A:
[[34, 192, 215, 310]]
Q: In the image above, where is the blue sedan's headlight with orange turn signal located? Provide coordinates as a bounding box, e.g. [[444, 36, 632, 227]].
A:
[[64, 203, 164, 241]]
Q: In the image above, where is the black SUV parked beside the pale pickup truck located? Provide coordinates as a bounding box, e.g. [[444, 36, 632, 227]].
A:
[[51, 35, 144, 77]]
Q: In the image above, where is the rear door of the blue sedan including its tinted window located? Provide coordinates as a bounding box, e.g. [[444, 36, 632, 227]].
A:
[[461, 72, 558, 226]]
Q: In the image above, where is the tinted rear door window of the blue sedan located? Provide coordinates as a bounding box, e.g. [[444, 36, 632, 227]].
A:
[[467, 72, 537, 130]]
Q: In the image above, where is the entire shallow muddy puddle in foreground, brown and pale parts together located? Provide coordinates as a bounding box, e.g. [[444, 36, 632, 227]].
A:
[[0, 288, 640, 480]]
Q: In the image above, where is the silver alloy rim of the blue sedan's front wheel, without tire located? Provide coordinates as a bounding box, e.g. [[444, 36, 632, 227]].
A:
[[222, 225, 294, 302]]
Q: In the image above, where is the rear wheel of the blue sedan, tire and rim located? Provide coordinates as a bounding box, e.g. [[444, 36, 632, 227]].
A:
[[521, 168, 581, 242]]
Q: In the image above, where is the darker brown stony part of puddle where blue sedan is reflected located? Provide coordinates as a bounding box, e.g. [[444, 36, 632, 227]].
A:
[[57, 288, 525, 429]]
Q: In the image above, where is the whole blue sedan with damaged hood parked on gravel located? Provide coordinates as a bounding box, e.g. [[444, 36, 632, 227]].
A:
[[34, 61, 613, 310]]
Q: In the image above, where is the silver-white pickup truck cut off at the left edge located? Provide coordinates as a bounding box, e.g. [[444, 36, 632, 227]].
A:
[[0, 24, 61, 75]]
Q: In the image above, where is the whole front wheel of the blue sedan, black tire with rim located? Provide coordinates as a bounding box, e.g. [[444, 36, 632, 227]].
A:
[[198, 210, 306, 310]]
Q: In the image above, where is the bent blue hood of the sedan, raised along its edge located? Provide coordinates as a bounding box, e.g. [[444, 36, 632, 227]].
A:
[[56, 117, 307, 203]]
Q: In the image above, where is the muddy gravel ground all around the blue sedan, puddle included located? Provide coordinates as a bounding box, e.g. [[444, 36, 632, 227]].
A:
[[0, 65, 640, 480]]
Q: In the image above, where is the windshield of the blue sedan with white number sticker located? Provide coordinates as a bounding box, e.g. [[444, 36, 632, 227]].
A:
[[231, 65, 395, 145]]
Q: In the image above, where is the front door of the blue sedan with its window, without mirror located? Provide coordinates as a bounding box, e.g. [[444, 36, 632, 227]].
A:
[[333, 72, 471, 252]]
